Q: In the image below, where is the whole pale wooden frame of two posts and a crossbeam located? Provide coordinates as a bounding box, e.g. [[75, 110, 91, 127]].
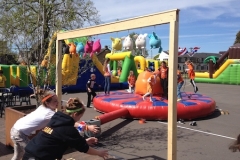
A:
[[56, 9, 179, 160]]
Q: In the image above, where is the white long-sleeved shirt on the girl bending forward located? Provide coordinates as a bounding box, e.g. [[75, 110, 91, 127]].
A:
[[13, 105, 55, 136]]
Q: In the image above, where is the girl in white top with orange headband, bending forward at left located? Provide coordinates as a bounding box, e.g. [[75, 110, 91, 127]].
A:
[[10, 89, 99, 160]]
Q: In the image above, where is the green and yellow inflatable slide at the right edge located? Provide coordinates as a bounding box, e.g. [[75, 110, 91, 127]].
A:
[[195, 43, 240, 85]]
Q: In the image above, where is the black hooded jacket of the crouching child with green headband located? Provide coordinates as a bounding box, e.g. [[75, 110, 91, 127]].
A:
[[25, 112, 89, 160]]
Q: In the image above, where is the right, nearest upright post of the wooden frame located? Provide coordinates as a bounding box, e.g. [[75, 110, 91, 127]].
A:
[[167, 12, 179, 160]]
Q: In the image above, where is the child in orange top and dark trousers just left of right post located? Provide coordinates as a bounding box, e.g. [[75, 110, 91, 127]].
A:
[[158, 61, 168, 99]]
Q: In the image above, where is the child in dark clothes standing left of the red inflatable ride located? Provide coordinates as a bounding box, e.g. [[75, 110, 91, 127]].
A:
[[86, 74, 101, 108]]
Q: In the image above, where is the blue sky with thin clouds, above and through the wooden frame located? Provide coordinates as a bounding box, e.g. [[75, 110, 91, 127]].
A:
[[93, 0, 240, 56]]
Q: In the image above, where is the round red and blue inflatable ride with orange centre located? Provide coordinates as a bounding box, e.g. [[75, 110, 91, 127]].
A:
[[93, 72, 216, 120]]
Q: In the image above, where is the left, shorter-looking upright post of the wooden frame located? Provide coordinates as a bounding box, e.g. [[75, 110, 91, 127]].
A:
[[55, 40, 62, 110]]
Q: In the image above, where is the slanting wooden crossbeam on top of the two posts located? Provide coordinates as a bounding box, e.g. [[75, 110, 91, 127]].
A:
[[57, 9, 178, 40]]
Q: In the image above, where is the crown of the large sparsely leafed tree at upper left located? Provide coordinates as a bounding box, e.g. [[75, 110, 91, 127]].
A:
[[0, 0, 100, 54]]
